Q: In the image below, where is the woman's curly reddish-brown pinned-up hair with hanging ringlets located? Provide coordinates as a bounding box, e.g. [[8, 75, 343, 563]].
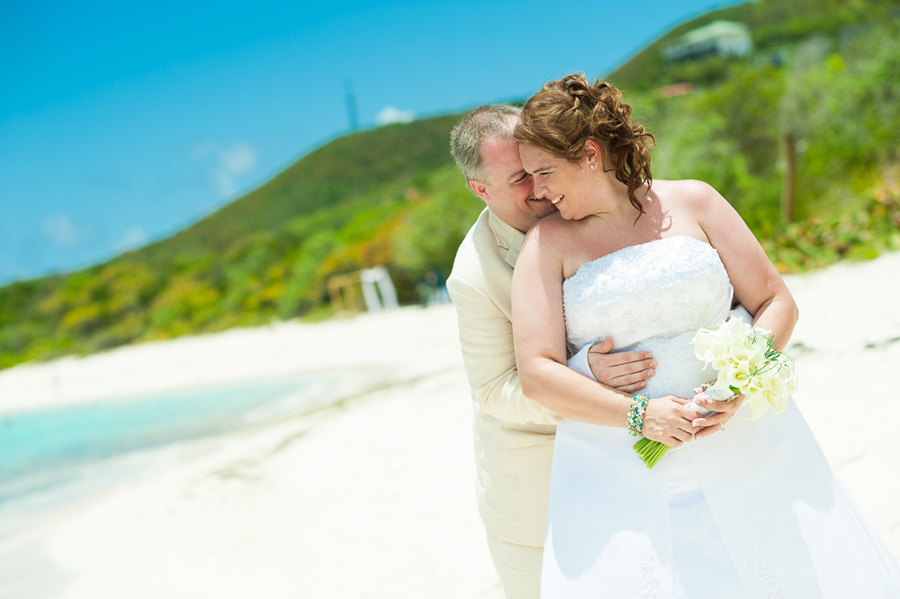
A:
[[514, 73, 655, 217]]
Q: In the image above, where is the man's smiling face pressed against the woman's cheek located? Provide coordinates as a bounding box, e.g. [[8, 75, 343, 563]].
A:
[[469, 139, 556, 232]]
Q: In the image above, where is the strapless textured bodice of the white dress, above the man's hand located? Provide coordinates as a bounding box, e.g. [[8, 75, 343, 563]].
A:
[[563, 236, 733, 351]]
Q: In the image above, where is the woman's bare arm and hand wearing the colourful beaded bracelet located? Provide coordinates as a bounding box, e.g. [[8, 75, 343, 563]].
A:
[[512, 222, 699, 446]]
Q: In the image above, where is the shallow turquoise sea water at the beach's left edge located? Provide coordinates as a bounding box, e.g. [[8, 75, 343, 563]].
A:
[[0, 373, 383, 540]]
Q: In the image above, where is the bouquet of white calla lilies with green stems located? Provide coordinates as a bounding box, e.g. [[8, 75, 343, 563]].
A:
[[634, 318, 797, 468]]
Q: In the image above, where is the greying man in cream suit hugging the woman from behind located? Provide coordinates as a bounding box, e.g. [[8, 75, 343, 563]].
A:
[[447, 104, 733, 599]]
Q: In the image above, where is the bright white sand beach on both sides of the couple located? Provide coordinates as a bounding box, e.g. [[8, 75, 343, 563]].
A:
[[0, 253, 900, 599]]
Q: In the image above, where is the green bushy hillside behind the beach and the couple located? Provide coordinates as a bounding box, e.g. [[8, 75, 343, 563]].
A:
[[0, 0, 900, 368]]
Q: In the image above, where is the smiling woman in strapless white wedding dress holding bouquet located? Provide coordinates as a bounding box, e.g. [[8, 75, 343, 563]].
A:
[[513, 75, 900, 599]]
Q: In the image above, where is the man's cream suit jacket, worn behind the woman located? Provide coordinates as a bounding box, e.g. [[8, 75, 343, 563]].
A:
[[447, 209, 560, 547]]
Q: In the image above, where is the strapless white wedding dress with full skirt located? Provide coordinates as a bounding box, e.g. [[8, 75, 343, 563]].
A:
[[541, 236, 900, 599]]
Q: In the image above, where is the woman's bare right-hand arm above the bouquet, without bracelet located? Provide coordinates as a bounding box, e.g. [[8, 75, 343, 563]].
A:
[[692, 181, 799, 349]]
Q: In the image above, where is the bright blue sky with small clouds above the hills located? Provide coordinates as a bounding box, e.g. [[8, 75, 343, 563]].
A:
[[0, 0, 737, 284]]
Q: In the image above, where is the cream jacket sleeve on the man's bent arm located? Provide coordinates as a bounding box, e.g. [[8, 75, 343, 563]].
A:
[[447, 277, 561, 424]]
